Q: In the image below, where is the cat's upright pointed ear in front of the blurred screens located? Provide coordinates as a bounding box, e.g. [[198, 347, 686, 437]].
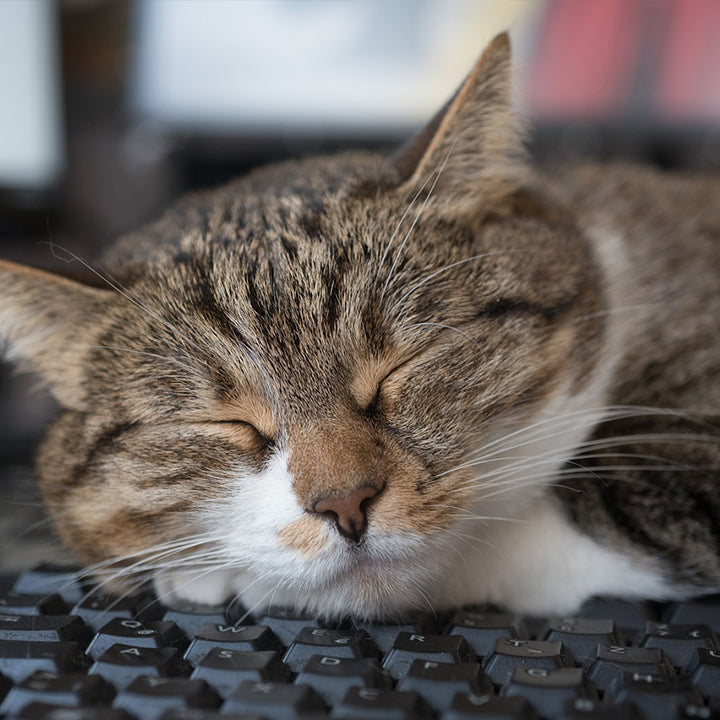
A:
[[390, 33, 524, 214]]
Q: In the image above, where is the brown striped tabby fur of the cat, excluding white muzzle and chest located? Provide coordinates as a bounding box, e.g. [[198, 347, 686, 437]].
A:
[[0, 36, 720, 608]]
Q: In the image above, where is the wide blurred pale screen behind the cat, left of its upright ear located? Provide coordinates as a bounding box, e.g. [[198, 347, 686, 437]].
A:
[[133, 0, 536, 137]]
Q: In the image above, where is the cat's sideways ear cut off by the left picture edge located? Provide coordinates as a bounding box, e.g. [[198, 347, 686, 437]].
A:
[[0, 260, 115, 410]]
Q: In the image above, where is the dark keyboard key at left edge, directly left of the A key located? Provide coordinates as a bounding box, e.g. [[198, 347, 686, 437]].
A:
[[0, 640, 89, 682]]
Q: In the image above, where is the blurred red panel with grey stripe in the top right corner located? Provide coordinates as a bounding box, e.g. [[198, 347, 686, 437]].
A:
[[526, 0, 720, 126]]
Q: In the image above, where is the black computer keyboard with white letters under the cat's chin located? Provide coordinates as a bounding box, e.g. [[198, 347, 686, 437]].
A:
[[0, 566, 720, 720]]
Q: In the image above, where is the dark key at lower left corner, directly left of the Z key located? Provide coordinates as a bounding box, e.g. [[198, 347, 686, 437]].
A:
[[0, 670, 115, 715]]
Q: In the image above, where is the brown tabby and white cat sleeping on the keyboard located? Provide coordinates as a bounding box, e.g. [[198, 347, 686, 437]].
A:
[[0, 35, 720, 617]]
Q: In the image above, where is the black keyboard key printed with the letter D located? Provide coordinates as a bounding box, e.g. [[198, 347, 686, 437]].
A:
[[295, 655, 390, 705]]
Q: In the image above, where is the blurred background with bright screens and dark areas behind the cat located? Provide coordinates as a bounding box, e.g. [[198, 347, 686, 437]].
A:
[[0, 0, 720, 569]]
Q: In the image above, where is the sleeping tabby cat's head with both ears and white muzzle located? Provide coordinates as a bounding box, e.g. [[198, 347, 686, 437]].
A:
[[0, 36, 604, 615]]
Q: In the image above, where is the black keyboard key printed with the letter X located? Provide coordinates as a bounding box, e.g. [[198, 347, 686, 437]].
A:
[[222, 681, 325, 720]]
